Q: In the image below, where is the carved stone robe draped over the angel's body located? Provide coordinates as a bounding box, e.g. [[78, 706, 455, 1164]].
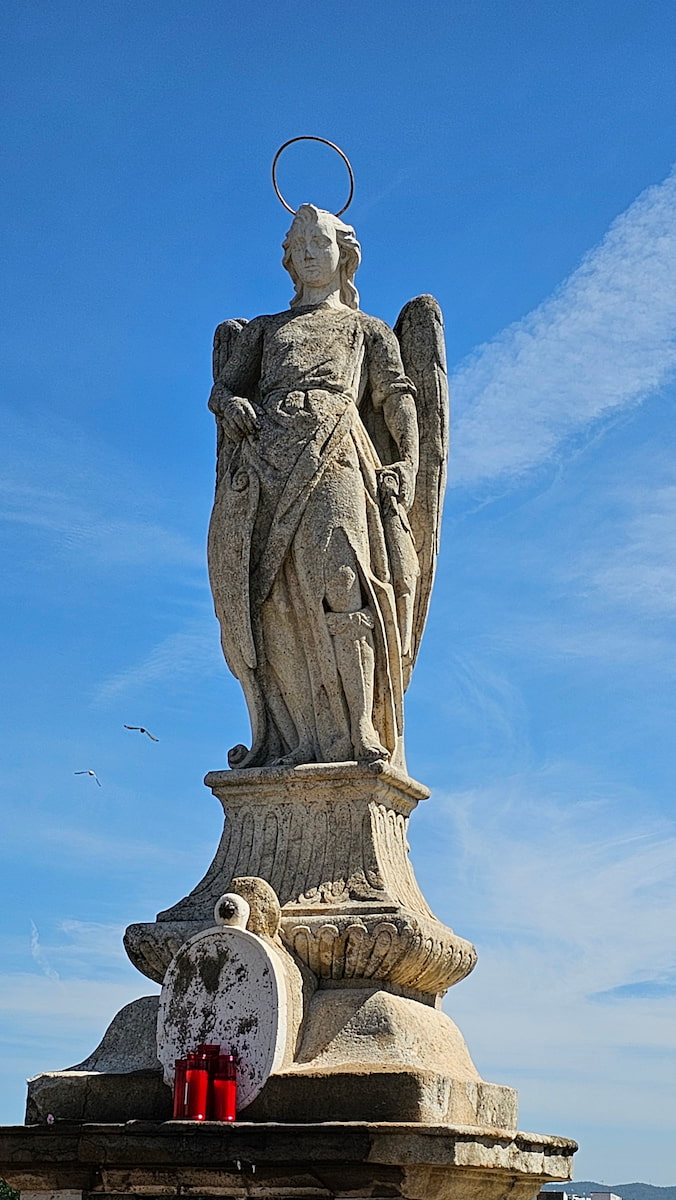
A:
[[209, 305, 415, 767]]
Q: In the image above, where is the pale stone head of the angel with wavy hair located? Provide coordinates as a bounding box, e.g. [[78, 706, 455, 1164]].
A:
[[282, 204, 361, 308]]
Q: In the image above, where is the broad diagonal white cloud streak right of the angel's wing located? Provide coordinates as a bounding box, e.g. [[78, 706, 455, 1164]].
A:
[[450, 172, 676, 486]]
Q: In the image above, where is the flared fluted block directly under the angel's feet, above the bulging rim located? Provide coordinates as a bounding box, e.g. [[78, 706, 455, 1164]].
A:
[[157, 763, 432, 922]]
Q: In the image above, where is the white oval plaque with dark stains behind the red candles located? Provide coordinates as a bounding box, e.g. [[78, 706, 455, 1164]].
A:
[[157, 925, 287, 1109]]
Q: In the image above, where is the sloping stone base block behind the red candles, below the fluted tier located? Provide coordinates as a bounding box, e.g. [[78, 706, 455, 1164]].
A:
[[26, 988, 518, 1129]]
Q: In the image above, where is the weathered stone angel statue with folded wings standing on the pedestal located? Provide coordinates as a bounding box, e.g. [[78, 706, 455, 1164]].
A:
[[209, 204, 448, 770]]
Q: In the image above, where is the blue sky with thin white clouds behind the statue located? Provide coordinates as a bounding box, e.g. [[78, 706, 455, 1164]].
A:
[[0, 0, 676, 1184]]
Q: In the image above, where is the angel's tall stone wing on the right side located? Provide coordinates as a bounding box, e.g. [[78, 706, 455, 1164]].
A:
[[394, 295, 449, 688]]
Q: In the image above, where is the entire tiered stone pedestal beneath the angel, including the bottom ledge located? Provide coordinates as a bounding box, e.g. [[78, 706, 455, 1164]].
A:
[[17, 763, 575, 1185]]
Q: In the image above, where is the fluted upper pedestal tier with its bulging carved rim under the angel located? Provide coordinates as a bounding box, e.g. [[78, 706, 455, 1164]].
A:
[[125, 762, 477, 1003]]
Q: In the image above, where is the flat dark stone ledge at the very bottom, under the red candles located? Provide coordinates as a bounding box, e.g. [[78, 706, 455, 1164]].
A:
[[0, 1121, 576, 1200]]
